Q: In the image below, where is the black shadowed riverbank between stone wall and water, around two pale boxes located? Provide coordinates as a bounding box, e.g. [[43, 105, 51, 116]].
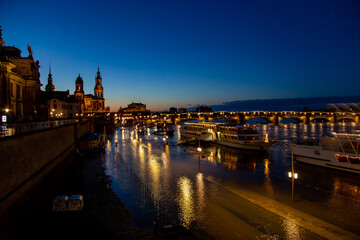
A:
[[15, 153, 153, 239]]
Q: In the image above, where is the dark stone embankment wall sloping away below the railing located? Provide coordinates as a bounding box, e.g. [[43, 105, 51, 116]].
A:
[[0, 121, 91, 213]]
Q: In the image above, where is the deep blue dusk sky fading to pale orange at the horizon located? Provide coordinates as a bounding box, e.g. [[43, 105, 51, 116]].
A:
[[0, 0, 360, 111]]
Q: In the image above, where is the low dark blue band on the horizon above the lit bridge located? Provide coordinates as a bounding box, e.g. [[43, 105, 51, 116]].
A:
[[193, 96, 360, 111]]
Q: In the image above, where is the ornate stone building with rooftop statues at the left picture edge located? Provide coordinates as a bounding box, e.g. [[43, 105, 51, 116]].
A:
[[0, 29, 42, 122]]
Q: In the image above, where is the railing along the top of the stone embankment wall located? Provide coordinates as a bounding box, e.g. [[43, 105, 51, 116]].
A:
[[0, 119, 80, 137]]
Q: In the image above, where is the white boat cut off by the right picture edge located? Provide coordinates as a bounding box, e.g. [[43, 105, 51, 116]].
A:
[[290, 133, 360, 173]]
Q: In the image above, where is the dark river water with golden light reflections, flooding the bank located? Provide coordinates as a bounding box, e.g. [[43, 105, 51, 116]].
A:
[[102, 123, 360, 239]]
